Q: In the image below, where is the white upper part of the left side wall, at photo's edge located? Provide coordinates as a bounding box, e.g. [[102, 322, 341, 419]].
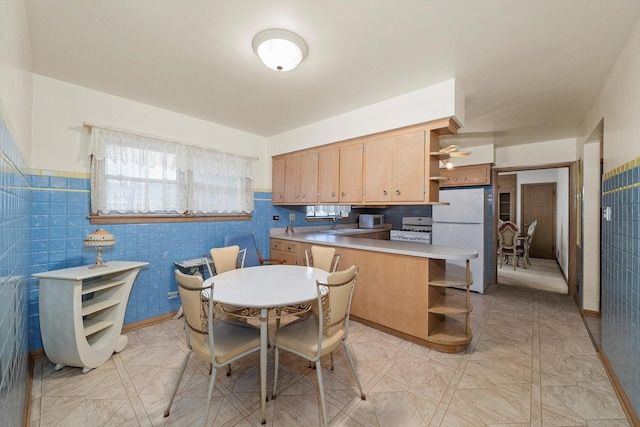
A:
[[0, 0, 33, 158]]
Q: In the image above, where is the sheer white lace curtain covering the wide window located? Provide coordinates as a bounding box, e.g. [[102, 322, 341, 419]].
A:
[[91, 126, 257, 215]]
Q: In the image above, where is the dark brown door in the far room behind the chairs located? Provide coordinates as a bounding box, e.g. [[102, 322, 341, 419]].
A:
[[520, 182, 556, 260]]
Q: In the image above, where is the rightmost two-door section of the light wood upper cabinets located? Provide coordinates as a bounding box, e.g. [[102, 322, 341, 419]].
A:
[[365, 131, 425, 202]]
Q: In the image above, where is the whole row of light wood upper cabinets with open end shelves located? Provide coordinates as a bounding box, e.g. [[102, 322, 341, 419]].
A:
[[271, 118, 458, 205]]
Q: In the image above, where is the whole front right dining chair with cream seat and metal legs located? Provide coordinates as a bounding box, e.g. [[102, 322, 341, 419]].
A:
[[273, 265, 366, 426]]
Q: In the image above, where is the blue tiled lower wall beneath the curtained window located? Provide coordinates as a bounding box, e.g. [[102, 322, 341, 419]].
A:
[[28, 188, 288, 351]]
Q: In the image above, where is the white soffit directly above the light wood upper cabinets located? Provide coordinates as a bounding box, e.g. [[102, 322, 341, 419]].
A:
[[269, 79, 464, 155]]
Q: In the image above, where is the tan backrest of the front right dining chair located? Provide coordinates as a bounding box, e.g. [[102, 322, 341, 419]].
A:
[[316, 265, 358, 339]]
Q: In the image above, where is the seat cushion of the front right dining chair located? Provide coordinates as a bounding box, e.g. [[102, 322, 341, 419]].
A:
[[275, 314, 344, 359]]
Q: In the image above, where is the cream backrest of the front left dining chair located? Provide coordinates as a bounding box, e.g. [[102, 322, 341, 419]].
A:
[[175, 270, 213, 360]]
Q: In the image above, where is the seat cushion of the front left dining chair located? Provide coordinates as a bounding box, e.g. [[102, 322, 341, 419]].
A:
[[191, 319, 260, 364]]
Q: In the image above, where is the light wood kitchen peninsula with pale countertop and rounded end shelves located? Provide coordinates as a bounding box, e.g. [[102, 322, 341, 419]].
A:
[[270, 229, 478, 352]]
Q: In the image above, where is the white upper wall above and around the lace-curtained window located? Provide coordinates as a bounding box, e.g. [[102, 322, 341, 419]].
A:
[[31, 75, 271, 189]]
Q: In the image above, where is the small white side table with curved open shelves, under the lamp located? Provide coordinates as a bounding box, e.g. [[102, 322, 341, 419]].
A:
[[33, 261, 149, 374]]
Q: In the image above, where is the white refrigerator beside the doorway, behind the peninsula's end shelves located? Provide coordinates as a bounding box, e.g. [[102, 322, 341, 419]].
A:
[[431, 188, 491, 294]]
